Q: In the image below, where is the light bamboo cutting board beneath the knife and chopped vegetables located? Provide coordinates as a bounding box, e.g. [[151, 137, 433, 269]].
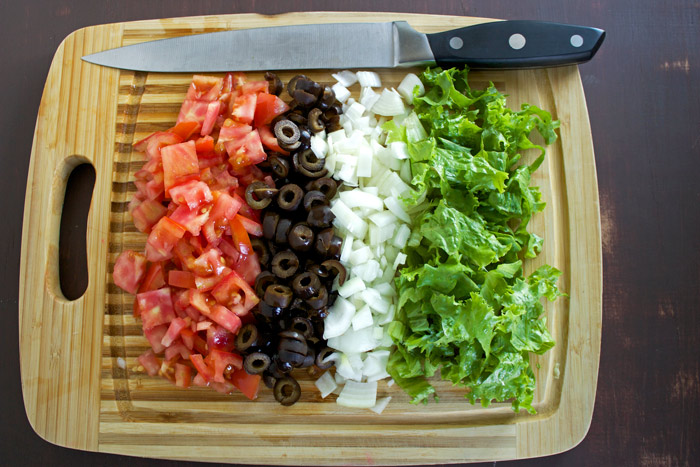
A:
[[19, 13, 602, 465]]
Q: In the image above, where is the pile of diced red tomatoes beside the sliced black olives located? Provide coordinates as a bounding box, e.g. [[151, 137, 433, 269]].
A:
[[114, 73, 289, 399]]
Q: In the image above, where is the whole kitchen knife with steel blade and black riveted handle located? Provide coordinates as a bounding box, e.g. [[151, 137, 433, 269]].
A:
[[83, 21, 605, 72]]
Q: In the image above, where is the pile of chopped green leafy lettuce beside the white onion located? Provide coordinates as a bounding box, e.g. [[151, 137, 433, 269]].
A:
[[385, 68, 563, 413]]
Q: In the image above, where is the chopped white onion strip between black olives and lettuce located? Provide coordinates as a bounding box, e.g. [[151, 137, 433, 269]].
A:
[[311, 70, 423, 413]]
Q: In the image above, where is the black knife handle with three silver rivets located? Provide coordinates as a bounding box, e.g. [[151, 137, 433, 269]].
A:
[[427, 20, 605, 69]]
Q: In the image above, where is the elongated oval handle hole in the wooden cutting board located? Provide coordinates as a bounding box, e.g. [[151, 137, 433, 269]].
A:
[[58, 164, 95, 300]]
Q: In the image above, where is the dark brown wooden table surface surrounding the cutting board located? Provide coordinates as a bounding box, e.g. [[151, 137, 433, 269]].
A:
[[0, 0, 700, 466]]
